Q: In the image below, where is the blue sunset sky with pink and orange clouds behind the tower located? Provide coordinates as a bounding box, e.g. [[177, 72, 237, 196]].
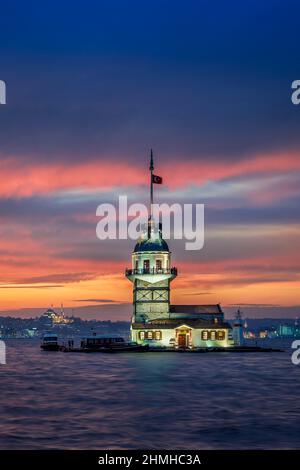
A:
[[0, 0, 300, 319]]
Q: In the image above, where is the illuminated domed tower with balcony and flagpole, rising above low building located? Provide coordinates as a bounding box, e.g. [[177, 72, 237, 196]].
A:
[[125, 150, 177, 323]]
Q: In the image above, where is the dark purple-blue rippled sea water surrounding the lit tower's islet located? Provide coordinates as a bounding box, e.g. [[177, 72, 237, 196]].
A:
[[0, 340, 300, 449]]
